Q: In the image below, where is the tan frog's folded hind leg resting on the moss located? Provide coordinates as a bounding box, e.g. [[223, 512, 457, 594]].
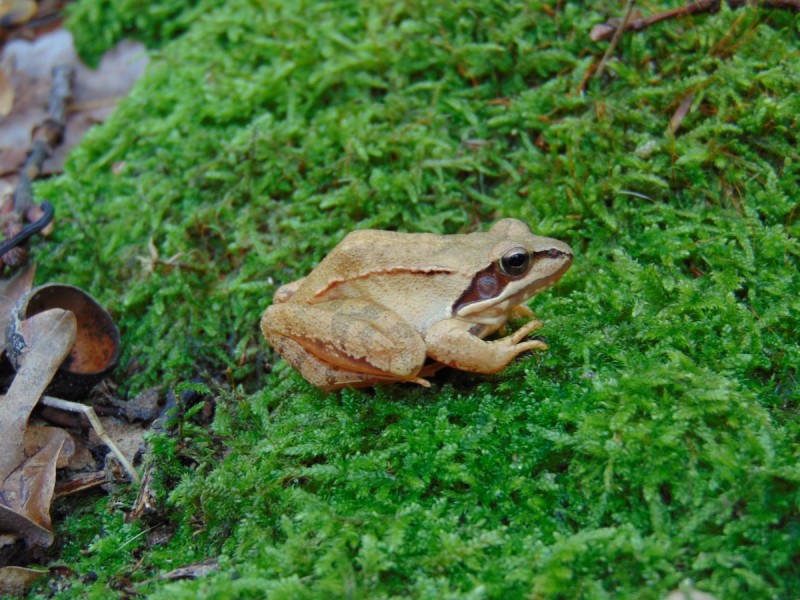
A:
[[261, 300, 427, 390]]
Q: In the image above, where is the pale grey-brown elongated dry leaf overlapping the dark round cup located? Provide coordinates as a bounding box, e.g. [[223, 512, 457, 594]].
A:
[[0, 309, 77, 482]]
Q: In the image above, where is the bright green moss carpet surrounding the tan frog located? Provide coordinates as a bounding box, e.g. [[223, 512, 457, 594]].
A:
[[28, 0, 800, 599]]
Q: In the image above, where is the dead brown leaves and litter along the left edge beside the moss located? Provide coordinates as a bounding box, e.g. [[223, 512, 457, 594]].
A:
[[0, 10, 155, 594]]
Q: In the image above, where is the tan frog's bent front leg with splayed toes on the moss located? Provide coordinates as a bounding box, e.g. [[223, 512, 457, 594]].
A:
[[425, 319, 547, 373]]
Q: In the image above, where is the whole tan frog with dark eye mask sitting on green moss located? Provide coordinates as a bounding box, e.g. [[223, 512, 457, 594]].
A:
[[261, 219, 572, 390]]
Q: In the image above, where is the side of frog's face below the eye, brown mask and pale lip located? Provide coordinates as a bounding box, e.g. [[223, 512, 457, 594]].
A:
[[452, 248, 573, 324]]
